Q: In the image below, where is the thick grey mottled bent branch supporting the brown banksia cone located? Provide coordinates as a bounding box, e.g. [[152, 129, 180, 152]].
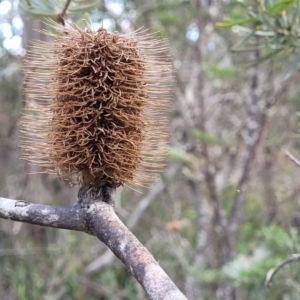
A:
[[0, 198, 187, 300]]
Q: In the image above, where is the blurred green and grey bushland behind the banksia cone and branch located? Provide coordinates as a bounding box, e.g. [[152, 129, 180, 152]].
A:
[[0, 0, 300, 300]]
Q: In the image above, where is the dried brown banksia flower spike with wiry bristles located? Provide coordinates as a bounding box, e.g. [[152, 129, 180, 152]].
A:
[[21, 23, 173, 190]]
